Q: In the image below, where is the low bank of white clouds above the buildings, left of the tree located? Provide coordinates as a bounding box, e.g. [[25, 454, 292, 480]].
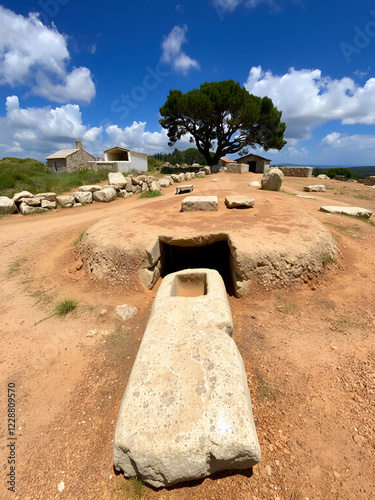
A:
[[0, 95, 191, 160]]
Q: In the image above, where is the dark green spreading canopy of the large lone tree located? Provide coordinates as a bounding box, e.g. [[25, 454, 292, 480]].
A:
[[159, 80, 286, 165]]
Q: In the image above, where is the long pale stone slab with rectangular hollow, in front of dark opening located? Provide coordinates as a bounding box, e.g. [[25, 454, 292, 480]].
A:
[[113, 269, 260, 487]]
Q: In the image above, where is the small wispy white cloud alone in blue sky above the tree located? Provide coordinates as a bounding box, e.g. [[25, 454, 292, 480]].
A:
[[161, 25, 200, 75]]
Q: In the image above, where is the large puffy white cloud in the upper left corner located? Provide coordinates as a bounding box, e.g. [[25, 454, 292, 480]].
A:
[[0, 6, 95, 103]]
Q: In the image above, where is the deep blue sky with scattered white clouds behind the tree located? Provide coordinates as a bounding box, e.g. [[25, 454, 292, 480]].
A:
[[0, 0, 375, 165]]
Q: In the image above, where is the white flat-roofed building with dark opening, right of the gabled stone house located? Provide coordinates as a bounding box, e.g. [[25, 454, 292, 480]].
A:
[[96, 147, 147, 172]]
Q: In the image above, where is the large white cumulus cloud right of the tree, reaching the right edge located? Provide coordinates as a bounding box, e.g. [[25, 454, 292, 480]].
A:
[[245, 66, 375, 140]]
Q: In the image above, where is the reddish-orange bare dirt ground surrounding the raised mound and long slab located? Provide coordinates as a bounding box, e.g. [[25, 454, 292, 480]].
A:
[[0, 173, 375, 500]]
